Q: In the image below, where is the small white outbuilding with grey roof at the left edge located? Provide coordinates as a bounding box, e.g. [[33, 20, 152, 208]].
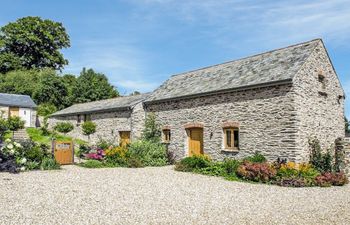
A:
[[0, 93, 37, 127]]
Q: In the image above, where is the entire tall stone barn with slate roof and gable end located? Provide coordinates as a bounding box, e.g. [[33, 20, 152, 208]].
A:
[[144, 39, 345, 162]]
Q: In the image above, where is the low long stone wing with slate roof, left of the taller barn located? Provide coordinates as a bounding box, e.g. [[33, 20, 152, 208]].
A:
[[48, 94, 148, 145]]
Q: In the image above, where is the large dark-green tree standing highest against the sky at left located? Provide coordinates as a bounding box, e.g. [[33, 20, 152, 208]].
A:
[[0, 16, 70, 73]]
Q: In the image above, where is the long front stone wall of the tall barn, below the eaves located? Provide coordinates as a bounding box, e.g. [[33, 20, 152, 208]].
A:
[[146, 85, 299, 160]]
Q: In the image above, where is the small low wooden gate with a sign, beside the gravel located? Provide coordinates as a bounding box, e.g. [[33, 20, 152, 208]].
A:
[[53, 141, 74, 165]]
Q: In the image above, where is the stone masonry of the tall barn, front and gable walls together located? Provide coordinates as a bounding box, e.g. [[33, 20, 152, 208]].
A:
[[145, 40, 345, 162]]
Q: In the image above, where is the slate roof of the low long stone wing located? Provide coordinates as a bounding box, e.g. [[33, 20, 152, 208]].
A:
[[52, 94, 149, 117]]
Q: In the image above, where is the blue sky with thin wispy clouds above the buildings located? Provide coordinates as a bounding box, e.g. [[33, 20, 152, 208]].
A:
[[0, 0, 350, 115]]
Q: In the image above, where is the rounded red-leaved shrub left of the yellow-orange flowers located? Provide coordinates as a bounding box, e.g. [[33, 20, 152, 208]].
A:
[[237, 161, 276, 182]]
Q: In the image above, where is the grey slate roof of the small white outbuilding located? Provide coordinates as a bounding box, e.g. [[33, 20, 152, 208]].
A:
[[0, 93, 36, 108]]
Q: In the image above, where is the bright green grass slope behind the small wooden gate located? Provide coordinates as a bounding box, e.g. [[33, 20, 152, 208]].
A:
[[26, 127, 86, 144]]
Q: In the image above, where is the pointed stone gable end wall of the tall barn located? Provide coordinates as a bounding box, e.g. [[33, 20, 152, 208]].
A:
[[293, 42, 345, 161]]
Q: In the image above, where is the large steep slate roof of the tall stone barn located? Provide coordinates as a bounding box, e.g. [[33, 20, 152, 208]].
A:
[[145, 39, 322, 103]]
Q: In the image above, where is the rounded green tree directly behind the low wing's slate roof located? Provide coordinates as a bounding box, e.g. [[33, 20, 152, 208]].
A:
[[73, 68, 119, 103]]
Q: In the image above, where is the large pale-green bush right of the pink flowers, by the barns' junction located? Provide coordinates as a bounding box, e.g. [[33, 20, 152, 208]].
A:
[[128, 140, 168, 166]]
